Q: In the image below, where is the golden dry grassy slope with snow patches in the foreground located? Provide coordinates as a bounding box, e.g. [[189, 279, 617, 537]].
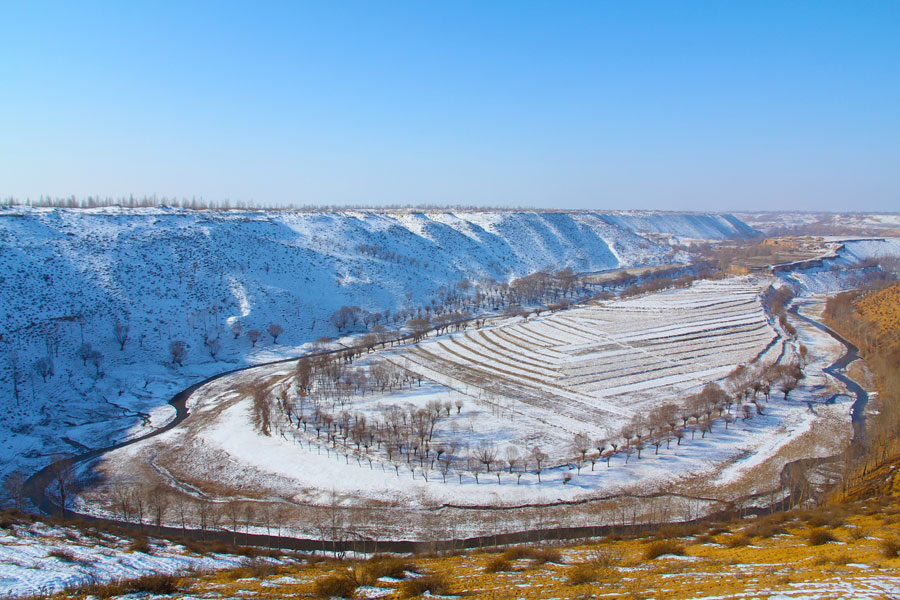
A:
[[31, 500, 900, 600]]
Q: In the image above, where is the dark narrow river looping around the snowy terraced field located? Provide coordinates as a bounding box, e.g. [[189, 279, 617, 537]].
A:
[[25, 304, 869, 554]]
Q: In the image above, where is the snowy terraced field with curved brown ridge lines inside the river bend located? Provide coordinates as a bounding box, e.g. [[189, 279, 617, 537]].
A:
[[391, 280, 781, 438]]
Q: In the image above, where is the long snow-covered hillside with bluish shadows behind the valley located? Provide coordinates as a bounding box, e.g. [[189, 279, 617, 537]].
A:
[[0, 208, 752, 488]]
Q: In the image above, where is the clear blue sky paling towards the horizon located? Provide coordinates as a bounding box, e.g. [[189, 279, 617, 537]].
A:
[[0, 0, 900, 211]]
